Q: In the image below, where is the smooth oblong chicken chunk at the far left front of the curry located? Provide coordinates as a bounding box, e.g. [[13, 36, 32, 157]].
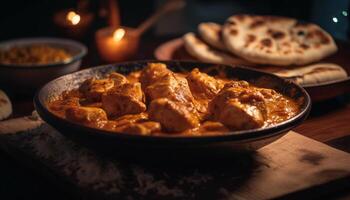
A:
[[65, 106, 108, 127]]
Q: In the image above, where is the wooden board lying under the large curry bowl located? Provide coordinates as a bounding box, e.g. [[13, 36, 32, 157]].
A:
[[0, 117, 350, 199]]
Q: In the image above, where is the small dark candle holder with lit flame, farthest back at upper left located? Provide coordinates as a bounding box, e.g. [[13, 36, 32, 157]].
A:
[[53, 9, 94, 38]]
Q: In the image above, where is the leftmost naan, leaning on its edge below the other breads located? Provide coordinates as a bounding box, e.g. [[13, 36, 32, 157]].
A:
[[183, 33, 251, 65]]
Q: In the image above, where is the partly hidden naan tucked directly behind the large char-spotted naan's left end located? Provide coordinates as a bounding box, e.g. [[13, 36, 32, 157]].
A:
[[198, 22, 227, 51]]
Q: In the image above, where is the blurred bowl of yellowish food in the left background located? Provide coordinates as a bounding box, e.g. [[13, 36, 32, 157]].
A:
[[0, 38, 87, 94]]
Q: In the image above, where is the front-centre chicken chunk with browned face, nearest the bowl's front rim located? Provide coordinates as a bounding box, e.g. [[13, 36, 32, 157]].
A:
[[148, 98, 199, 132]]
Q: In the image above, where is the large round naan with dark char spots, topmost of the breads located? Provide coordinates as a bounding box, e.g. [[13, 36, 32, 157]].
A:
[[222, 15, 337, 66]]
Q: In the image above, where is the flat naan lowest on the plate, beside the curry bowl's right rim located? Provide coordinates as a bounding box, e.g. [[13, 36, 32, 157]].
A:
[[274, 63, 348, 86]]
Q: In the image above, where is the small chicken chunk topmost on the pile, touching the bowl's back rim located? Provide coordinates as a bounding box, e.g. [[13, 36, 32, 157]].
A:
[[140, 63, 172, 88]]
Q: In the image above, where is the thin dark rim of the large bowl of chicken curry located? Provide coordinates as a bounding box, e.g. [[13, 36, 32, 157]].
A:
[[33, 60, 312, 143]]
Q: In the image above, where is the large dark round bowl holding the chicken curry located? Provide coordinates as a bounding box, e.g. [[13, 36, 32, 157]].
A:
[[34, 61, 311, 152]]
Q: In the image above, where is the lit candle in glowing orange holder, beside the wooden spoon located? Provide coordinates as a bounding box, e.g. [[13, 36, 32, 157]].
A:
[[96, 27, 139, 62]]
